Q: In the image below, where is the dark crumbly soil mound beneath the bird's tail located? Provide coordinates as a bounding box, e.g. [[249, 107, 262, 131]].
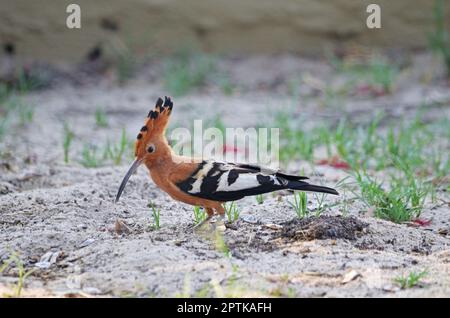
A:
[[277, 215, 369, 241]]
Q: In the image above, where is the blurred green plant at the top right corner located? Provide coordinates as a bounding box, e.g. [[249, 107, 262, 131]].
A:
[[428, 0, 450, 78]]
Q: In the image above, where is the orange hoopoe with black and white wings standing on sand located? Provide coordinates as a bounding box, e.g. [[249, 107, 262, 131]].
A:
[[115, 97, 338, 224]]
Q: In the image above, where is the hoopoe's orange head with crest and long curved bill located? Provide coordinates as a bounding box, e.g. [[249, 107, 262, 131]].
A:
[[116, 96, 173, 202]]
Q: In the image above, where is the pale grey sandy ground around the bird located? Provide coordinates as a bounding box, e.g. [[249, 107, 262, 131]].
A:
[[0, 56, 450, 297]]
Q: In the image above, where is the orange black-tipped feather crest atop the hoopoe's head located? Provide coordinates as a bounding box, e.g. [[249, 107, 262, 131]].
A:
[[135, 96, 173, 154]]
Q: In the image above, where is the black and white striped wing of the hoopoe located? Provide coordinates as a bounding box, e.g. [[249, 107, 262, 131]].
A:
[[177, 161, 292, 202]]
